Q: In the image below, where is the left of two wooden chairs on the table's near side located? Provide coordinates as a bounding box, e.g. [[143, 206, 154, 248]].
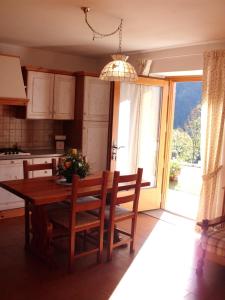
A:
[[49, 172, 108, 271]]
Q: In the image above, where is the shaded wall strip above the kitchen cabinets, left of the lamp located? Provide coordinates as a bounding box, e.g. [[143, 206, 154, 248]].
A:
[[0, 43, 98, 72]]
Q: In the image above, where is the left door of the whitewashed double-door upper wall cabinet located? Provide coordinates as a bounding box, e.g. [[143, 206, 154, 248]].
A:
[[27, 71, 54, 119]]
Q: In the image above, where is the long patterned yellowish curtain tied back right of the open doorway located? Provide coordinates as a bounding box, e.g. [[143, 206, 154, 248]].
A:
[[198, 50, 225, 220]]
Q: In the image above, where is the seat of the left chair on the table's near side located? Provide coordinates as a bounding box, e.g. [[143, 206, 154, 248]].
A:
[[49, 208, 100, 229]]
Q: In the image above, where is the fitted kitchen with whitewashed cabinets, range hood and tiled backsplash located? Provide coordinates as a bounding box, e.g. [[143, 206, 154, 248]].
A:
[[0, 55, 110, 218]]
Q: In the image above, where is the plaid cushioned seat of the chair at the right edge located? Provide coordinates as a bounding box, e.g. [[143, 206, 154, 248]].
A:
[[202, 228, 225, 256]]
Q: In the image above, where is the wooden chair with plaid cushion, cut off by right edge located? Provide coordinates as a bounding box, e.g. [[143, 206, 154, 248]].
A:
[[196, 216, 225, 275]]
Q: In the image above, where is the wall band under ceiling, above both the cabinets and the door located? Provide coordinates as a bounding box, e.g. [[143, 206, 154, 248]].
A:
[[3, 42, 225, 73]]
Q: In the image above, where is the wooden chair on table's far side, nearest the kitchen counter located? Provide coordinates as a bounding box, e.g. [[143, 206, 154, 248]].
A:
[[23, 158, 56, 248]]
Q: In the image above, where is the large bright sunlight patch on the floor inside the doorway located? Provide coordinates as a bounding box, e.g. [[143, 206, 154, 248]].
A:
[[110, 221, 199, 300]]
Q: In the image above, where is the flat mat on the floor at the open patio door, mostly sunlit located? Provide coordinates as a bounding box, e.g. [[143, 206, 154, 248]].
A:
[[143, 209, 196, 228]]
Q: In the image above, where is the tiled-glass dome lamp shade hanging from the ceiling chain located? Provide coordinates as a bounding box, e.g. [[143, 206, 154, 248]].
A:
[[99, 54, 138, 82]]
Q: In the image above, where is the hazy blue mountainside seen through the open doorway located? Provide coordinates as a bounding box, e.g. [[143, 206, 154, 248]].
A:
[[173, 81, 202, 129]]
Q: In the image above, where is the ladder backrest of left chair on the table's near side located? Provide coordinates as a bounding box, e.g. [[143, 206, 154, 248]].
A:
[[70, 171, 109, 226]]
